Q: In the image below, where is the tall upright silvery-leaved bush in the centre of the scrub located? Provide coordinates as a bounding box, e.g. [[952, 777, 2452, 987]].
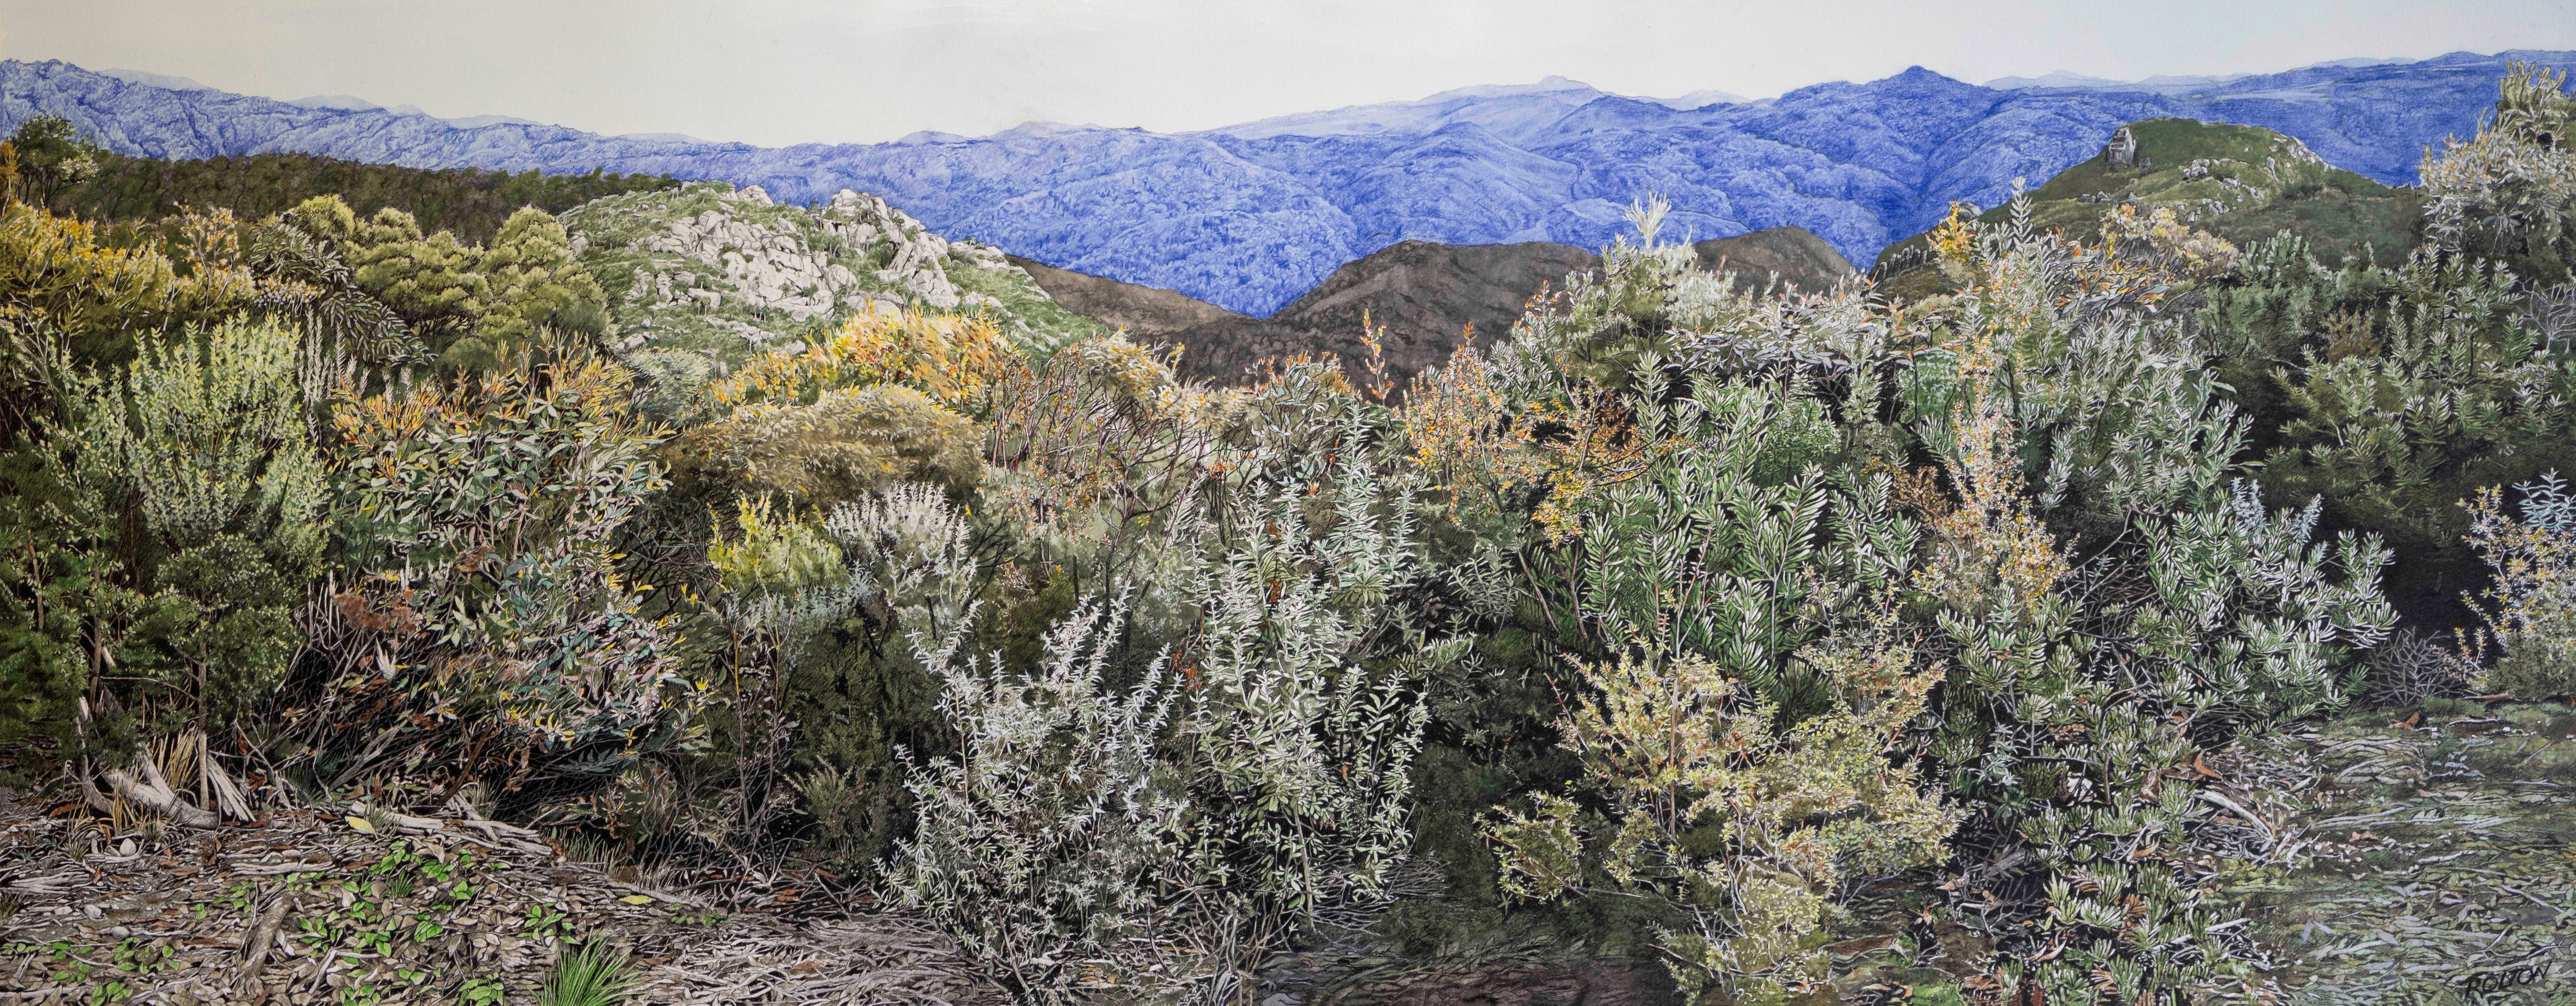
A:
[[1182, 431, 1458, 947]]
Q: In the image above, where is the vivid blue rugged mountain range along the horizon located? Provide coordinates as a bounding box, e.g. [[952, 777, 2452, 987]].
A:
[[0, 52, 2576, 315]]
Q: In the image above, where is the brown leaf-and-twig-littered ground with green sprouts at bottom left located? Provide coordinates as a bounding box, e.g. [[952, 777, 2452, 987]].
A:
[[0, 792, 1007, 1006]]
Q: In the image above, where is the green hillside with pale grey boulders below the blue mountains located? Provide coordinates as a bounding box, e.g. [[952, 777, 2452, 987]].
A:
[[564, 180, 1102, 371]]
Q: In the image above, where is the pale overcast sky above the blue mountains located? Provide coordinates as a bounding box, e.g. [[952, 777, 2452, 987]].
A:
[[0, 0, 2576, 144]]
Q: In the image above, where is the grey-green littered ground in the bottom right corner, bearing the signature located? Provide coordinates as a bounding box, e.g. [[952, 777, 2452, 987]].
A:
[[2223, 699, 2576, 1006]]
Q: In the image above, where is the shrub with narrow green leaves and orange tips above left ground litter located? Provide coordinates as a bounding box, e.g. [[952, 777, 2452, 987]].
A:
[[296, 359, 701, 792]]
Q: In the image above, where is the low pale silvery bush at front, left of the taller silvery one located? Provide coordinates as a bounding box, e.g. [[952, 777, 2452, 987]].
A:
[[886, 601, 1187, 1001]]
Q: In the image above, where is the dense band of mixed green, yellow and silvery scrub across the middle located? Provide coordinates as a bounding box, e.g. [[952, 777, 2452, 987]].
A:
[[0, 70, 2576, 1006]]
